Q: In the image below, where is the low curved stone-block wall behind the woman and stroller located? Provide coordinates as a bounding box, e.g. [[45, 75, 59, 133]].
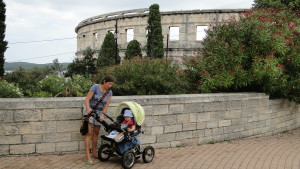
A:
[[0, 93, 300, 156]]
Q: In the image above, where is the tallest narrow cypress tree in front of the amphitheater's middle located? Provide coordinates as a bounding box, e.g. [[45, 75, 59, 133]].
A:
[[147, 4, 164, 58]]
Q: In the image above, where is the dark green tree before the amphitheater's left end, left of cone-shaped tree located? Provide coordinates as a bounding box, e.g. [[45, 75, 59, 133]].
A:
[[65, 48, 97, 77]]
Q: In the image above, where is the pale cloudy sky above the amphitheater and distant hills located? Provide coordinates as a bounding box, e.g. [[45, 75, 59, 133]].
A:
[[4, 0, 254, 64]]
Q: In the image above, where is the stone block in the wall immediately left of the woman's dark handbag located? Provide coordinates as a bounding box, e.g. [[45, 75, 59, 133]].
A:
[[56, 120, 82, 132]]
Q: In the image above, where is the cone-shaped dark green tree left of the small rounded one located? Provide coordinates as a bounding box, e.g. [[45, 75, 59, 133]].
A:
[[97, 32, 119, 68]]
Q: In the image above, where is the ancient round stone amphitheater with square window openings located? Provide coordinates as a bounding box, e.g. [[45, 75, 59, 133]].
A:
[[75, 8, 247, 58]]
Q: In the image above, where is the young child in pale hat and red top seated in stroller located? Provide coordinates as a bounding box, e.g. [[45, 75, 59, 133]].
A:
[[107, 110, 135, 142]]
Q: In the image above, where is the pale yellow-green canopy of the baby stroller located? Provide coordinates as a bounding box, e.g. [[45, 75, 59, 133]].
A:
[[115, 102, 145, 126]]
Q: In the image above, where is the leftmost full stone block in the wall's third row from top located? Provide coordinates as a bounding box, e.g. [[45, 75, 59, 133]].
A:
[[3, 123, 30, 135]]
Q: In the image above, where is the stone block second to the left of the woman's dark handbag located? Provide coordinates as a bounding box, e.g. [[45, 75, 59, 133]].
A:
[[30, 121, 56, 134]]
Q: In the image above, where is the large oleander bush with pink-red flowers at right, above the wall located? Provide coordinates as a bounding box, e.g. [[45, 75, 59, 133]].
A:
[[186, 9, 300, 102]]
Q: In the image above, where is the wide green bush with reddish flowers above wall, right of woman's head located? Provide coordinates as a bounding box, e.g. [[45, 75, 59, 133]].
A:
[[95, 58, 185, 95]]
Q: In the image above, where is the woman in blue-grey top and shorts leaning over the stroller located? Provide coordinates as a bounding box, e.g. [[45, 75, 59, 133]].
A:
[[84, 75, 115, 165]]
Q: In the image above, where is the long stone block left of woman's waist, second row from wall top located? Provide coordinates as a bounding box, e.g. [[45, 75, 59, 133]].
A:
[[42, 108, 82, 120]]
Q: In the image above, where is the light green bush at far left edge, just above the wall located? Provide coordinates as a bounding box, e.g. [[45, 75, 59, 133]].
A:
[[0, 80, 23, 98]]
